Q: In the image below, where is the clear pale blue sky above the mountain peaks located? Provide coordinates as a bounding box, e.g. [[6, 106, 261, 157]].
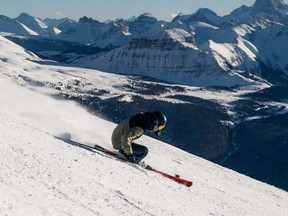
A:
[[0, 0, 288, 21]]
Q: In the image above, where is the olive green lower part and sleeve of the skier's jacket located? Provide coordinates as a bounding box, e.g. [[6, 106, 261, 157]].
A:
[[111, 118, 144, 155]]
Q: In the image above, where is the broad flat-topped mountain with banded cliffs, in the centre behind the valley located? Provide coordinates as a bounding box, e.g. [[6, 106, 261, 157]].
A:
[[87, 29, 266, 86]]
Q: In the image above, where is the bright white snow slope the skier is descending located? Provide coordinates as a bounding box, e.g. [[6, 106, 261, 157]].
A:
[[0, 34, 288, 216]]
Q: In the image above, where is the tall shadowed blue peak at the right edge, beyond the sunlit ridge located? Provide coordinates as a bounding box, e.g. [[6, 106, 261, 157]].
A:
[[226, 0, 288, 85]]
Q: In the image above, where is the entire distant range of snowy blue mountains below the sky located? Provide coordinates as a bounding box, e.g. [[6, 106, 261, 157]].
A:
[[0, 0, 288, 87]]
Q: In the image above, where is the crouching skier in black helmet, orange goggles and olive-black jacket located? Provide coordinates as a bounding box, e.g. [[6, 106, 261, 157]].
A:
[[111, 111, 167, 163]]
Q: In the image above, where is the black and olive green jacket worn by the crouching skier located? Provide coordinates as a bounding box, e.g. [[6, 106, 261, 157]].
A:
[[111, 112, 155, 155]]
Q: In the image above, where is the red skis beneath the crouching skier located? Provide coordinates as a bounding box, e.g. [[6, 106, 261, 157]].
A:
[[94, 145, 193, 187]]
